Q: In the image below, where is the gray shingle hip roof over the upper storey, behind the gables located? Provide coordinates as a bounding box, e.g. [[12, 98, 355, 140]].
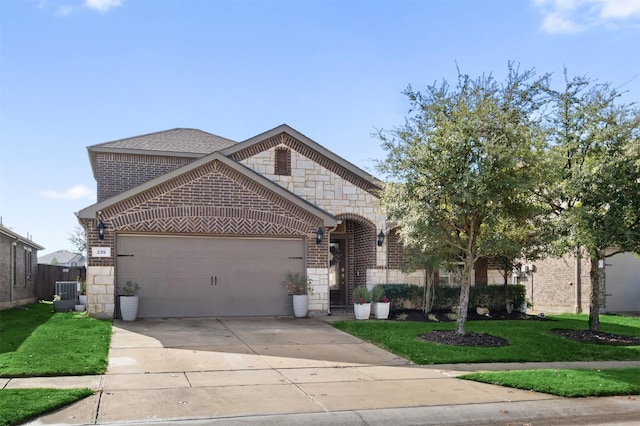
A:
[[89, 128, 236, 154]]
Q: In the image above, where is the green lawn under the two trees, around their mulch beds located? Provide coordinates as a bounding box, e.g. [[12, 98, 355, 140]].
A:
[[334, 314, 640, 365]]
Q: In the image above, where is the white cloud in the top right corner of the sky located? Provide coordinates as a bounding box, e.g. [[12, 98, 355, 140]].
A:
[[533, 0, 640, 34]]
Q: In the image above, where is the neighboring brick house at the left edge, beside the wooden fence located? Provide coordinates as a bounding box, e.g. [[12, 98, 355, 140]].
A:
[[0, 225, 44, 309]]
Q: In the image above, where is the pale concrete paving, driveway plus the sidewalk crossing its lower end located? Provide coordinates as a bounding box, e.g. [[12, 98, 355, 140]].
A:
[[6, 318, 640, 425]]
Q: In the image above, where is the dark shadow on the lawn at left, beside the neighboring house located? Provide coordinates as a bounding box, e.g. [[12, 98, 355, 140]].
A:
[[0, 303, 54, 353]]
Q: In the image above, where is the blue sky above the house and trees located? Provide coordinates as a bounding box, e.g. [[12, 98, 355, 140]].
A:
[[0, 0, 640, 254]]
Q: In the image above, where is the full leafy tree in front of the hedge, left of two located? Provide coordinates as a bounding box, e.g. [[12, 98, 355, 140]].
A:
[[378, 64, 546, 334]]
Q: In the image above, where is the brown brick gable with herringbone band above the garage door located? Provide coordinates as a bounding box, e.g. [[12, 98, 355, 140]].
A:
[[103, 161, 320, 235]]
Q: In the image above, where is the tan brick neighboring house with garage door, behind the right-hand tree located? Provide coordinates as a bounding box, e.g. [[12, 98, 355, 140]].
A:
[[518, 253, 640, 313]]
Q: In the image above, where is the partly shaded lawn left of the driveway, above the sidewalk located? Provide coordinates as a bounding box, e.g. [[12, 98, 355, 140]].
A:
[[0, 303, 111, 377]]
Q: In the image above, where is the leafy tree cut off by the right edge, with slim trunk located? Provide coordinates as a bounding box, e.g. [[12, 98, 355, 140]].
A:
[[539, 75, 640, 331]]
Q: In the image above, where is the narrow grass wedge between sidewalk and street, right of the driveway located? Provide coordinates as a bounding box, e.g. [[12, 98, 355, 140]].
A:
[[459, 368, 640, 398]]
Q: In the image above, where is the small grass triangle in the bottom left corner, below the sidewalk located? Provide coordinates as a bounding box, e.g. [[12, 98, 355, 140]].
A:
[[0, 389, 93, 426]]
